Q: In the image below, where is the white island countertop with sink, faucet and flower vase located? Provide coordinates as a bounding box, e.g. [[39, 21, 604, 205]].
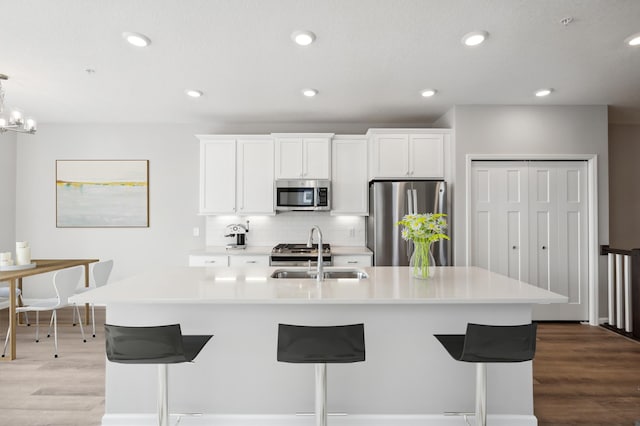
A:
[[70, 266, 567, 304]]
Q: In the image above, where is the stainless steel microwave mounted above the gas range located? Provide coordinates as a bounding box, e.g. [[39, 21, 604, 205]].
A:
[[275, 179, 331, 211]]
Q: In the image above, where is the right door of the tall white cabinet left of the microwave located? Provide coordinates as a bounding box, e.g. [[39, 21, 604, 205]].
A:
[[237, 139, 274, 214]]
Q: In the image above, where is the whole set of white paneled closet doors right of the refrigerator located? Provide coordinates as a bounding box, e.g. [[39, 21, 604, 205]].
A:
[[469, 161, 589, 321]]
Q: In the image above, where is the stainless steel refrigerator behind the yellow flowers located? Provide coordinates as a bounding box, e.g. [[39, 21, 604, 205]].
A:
[[367, 180, 451, 266]]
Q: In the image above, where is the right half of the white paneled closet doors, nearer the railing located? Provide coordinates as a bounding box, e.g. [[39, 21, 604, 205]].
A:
[[529, 161, 589, 321]]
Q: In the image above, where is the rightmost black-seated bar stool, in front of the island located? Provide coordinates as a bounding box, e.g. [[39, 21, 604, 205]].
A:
[[434, 323, 538, 426]]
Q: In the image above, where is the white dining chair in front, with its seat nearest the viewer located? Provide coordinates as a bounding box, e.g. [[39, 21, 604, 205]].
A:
[[2, 266, 87, 358]]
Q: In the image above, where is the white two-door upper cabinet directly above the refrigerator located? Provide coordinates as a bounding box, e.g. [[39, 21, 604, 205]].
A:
[[369, 129, 445, 179]]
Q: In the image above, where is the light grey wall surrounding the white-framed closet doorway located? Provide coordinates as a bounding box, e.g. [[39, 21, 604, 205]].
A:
[[454, 105, 609, 313]]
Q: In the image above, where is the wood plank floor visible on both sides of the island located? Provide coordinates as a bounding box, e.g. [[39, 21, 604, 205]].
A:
[[0, 311, 640, 426]]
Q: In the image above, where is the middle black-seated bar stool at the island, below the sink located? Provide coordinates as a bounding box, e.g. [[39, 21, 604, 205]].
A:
[[278, 324, 365, 426]]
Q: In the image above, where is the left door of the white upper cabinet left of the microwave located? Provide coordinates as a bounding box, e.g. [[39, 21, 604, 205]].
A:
[[200, 139, 236, 214]]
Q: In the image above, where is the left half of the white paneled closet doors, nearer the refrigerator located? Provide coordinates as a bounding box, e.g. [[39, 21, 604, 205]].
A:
[[471, 161, 529, 280]]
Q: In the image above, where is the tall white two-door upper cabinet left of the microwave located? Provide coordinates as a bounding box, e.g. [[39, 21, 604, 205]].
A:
[[198, 135, 275, 215]]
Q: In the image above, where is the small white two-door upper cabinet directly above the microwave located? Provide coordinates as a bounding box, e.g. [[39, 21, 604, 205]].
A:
[[272, 133, 333, 179]]
